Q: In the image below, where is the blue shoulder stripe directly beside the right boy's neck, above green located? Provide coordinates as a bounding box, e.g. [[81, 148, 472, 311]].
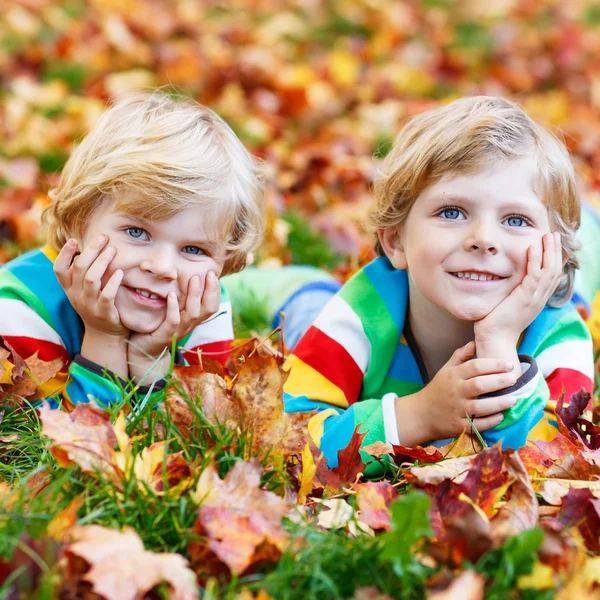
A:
[[363, 256, 408, 332]]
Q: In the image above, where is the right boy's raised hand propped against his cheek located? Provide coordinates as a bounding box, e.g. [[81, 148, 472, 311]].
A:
[[475, 233, 563, 358]]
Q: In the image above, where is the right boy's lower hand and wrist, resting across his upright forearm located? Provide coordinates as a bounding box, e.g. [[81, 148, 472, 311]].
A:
[[396, 342, 516, 447]]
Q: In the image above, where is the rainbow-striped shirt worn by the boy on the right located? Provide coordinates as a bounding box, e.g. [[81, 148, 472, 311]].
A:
[[284, 257, 594, 466]]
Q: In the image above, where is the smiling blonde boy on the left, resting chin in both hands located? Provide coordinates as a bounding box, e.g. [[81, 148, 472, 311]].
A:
[[0, 93, 264, 406]]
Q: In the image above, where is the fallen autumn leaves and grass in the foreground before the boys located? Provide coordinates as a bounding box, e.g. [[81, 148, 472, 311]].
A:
[[0, 339, 600, 600]]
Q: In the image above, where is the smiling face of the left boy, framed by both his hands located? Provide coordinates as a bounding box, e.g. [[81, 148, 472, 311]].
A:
[[75, 200, 225, 333]]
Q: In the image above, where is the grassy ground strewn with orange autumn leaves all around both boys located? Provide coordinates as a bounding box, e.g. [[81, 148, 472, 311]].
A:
[[0, 0, 600, 600]]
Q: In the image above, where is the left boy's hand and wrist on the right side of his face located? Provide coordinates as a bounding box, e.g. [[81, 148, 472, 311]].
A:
[[128, 271, 221, 378]]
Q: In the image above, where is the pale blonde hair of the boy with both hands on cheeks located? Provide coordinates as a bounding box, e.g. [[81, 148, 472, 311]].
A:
[[42, 92, 265, 274]]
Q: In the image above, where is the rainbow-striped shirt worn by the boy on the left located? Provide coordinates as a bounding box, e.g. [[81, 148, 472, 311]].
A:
[[0, 246, 233, 407]]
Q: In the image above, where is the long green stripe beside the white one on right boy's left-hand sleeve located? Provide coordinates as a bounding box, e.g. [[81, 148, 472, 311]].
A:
[[339, 270, 400, 400]]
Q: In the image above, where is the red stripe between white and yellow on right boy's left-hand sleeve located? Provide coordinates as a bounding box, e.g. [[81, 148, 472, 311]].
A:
[[294, 325, 363, 404]]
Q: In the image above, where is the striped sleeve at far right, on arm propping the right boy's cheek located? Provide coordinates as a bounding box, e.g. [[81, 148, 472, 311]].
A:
[[482, 304, 594, 448]]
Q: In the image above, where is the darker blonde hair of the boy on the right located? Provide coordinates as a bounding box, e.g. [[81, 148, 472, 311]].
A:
[[369, 96, 581, 307]]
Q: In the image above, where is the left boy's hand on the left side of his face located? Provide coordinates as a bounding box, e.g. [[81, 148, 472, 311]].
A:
[[54, 235, 130, 338]]
